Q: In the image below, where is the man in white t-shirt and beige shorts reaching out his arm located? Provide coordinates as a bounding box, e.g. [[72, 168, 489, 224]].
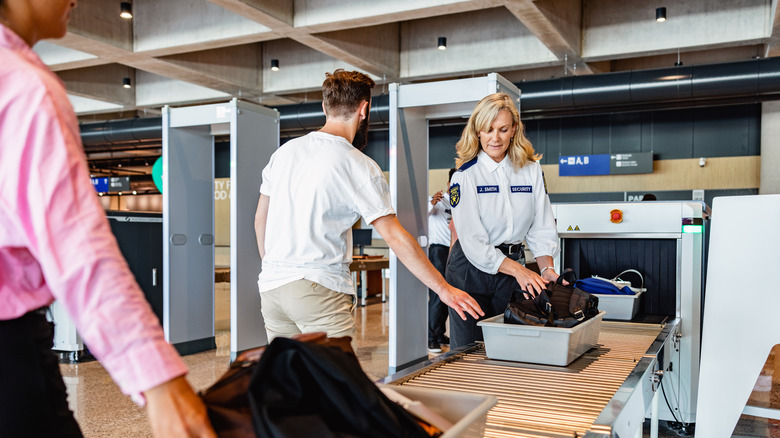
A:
[[255, 69, 483, 342]]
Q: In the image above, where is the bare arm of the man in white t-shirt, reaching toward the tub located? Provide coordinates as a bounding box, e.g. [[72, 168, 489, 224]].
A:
[[371, 214, 485, 321]]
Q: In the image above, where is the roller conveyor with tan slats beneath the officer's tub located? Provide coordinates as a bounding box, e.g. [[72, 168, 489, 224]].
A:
[[390, 322, 663, 438]]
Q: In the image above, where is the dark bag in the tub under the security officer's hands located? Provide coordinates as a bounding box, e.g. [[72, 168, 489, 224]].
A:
[[504, 269, 599, 328]]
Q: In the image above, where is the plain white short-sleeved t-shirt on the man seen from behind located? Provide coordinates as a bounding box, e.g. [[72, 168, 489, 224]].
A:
[[257, 132, 395, 294]]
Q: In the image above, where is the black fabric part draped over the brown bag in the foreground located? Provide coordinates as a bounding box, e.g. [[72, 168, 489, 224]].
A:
[[248, 338, 429, 438]]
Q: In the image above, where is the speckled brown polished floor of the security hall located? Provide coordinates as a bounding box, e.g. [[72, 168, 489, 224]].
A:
[[61, 283, 780, 438]]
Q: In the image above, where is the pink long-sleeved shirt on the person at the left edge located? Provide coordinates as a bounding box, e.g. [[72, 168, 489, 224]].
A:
[[0, 24, 187, 404]]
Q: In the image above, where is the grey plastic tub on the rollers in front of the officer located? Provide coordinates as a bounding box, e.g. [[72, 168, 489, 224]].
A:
[[477, 311, 606, 366]]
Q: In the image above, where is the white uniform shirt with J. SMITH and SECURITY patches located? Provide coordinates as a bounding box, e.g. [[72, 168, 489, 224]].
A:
[[450, 151, 558, 274]]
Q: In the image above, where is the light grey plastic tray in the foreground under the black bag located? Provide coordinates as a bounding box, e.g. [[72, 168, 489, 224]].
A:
[[380, 385, 498, 438]]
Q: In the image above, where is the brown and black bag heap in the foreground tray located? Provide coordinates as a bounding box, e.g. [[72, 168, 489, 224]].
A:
[[200, 333, 441, 438]]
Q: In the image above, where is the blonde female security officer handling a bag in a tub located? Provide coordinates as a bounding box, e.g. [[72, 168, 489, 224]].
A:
[[446, 93, 558, 348]]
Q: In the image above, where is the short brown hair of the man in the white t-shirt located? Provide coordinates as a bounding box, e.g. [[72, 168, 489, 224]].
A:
[[322, 68, 375, 118]]
